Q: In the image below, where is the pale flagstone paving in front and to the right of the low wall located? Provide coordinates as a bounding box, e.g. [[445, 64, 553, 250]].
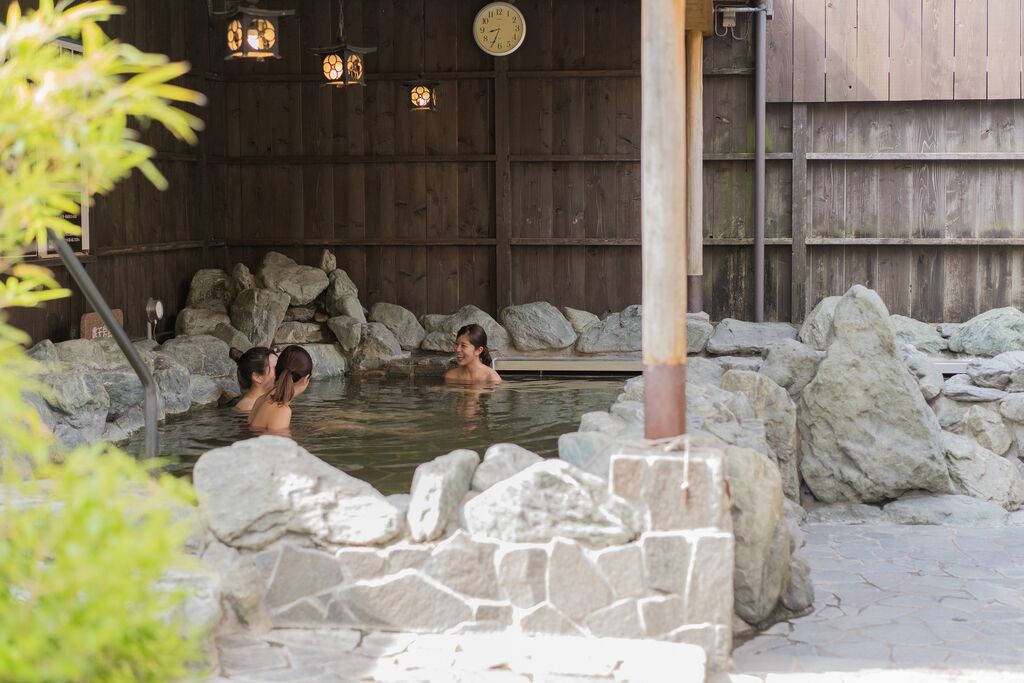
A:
[[215, 524, 1024, 683]]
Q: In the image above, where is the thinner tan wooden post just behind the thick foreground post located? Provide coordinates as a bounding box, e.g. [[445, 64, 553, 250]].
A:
[[686, 31, 703, 313]]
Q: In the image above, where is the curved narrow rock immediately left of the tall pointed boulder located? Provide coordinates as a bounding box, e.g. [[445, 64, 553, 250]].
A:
[[722, 370, 800, 501]]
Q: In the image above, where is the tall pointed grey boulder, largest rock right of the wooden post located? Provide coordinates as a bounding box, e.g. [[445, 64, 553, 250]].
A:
[[799, 285, 950, 503]]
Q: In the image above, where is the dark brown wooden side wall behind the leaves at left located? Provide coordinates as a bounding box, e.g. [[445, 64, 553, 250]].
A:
[[11, 0, 226, 340]]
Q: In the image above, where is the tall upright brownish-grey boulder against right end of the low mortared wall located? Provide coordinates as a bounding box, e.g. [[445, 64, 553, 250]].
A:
[[725, 446, 791, 624]]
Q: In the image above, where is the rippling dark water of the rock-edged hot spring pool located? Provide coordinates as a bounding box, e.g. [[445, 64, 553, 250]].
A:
[[128, 378, 623, 494]]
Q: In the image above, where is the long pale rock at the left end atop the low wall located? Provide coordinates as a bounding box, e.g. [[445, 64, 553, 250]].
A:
[[193, 436, 402, 550]]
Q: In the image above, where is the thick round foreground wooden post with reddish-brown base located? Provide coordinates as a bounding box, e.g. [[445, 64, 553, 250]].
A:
[[640, 0, 687, 439]]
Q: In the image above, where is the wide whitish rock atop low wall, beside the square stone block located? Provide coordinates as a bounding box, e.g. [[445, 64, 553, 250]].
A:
[[463, 460, 642, 547]]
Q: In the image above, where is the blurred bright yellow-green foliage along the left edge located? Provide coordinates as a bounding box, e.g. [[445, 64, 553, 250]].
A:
[[0, 0, 209, 683]]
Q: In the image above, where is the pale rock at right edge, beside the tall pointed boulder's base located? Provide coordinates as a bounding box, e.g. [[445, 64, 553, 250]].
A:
[[942, 432, 1024, 510]]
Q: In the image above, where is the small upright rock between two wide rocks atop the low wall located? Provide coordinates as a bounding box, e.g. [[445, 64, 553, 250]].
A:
[[407, 450, 480, 543]]
